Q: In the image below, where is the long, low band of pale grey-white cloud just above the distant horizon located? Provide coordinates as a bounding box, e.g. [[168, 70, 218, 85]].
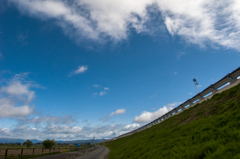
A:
[[0, 124, 122, 141]]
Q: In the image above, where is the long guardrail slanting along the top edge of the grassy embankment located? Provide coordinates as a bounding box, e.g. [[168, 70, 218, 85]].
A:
[[116, 67, 240, 139]]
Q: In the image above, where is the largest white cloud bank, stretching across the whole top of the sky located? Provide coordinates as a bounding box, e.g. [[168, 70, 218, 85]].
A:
[[10, 0, 240, 51]]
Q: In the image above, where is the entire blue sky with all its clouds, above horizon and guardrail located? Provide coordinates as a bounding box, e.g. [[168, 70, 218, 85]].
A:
[[0, 0, 240, 140]]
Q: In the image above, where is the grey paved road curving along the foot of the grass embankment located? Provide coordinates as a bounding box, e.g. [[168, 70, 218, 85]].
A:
[[75, 146, 110, 159]]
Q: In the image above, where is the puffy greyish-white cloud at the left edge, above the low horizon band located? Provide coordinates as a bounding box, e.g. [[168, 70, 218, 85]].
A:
[[0, 73, 35, 118]]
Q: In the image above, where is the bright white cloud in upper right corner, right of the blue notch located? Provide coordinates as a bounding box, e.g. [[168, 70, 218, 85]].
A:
[[158, 0, 240, 50]]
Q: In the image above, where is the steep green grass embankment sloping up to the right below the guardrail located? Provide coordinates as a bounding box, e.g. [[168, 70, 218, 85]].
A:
[[105, 84, 240, 159]]
